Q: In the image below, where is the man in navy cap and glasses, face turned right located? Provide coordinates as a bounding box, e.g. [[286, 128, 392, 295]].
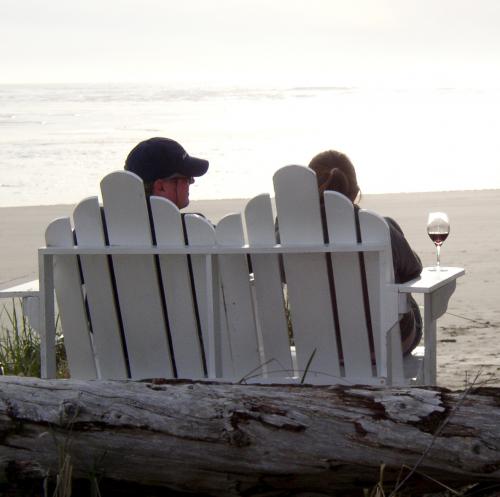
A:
[[125, 137, 208, 209]]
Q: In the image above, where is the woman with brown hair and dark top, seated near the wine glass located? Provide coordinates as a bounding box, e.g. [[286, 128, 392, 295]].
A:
[[309, 150, 422, 354]]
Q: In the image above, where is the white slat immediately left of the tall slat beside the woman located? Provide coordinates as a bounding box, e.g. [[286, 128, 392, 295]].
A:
[[245, 194, 293, 376]]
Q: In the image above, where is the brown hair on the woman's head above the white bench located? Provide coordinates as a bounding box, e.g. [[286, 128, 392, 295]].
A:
[[309, 150, 360, 202]]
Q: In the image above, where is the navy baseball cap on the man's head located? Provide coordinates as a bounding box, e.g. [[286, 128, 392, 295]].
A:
[[125, 137, 208, 182]]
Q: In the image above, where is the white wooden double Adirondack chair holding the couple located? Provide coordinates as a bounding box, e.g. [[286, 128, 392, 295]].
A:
[[39, 166, 463, 385]]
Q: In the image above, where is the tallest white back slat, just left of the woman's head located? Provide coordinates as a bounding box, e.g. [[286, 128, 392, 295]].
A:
[[273, 166, 340, 383]]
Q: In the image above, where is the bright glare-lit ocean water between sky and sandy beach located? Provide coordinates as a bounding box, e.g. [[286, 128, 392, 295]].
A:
[[0, 85, 500, 206]]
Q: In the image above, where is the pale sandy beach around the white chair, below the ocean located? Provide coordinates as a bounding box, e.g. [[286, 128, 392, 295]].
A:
[[0, 190, 500, 389]]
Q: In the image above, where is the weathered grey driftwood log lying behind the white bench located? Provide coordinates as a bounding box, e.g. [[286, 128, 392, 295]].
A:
[[0, 377, 500, 496]]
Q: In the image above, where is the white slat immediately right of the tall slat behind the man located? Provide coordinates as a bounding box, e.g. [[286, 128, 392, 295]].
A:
[[150, 197, 205, 378]]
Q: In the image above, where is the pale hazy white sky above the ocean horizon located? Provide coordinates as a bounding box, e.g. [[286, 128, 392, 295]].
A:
[[0, 0, 500, 87]]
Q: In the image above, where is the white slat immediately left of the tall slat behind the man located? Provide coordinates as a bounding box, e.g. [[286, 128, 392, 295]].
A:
[[73, 197, 128, 379]]
